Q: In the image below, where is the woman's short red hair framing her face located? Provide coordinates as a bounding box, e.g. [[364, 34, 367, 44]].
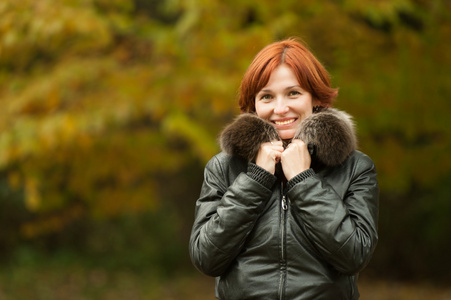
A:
[[239, 38, 338, 113]]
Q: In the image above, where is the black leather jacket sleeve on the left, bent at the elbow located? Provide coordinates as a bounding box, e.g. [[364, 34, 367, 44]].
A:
[[189, 157, 276, 276]]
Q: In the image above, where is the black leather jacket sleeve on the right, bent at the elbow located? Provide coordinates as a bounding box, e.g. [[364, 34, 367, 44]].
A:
[[287, 155, 379, 275]]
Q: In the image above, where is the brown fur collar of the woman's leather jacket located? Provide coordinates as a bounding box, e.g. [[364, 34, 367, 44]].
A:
[[219, 108, 357, 167]]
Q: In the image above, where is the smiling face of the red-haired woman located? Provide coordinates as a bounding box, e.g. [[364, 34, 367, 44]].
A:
[[255, 64, 319, 140]]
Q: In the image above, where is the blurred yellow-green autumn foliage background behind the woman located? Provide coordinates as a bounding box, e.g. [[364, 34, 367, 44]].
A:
[[0, 0, 451, 299]]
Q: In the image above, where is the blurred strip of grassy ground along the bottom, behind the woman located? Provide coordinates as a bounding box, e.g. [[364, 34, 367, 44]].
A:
[[0, 265, 451, 300]]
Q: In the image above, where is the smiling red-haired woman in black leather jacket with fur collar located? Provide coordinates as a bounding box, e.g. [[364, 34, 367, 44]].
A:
[[190, 39, 379, 300]]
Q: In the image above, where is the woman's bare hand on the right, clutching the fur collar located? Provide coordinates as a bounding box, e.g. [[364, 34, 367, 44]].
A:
[[281, 140, 312, 180]]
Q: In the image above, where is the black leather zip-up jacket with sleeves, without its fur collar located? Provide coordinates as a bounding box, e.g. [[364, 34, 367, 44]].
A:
[[190, 109, 379, 300]]
